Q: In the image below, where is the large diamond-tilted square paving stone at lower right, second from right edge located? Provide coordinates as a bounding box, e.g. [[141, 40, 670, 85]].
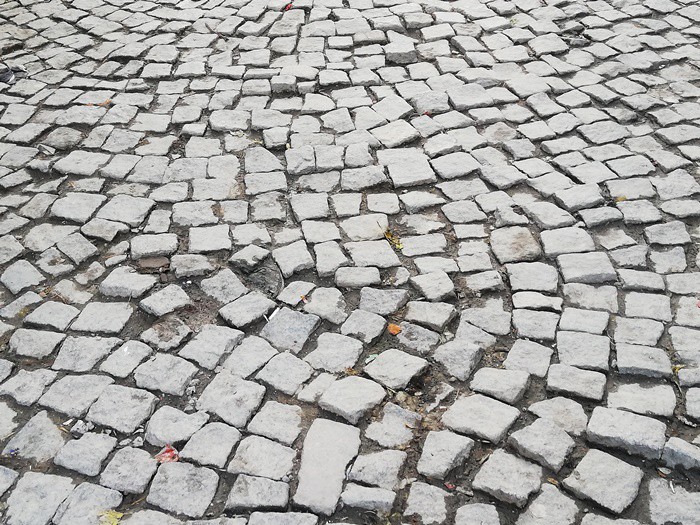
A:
[[562, 449, 644, 514]]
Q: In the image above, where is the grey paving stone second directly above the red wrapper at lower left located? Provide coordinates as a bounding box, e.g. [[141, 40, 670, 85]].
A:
[[134, 354, 199, 396]]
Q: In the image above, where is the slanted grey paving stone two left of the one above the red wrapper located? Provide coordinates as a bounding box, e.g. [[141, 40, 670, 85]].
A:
[[39, 375, 114, 417]]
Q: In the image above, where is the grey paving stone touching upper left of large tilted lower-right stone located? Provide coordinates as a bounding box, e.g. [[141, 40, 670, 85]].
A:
[[508, 418, 576, 472]]
